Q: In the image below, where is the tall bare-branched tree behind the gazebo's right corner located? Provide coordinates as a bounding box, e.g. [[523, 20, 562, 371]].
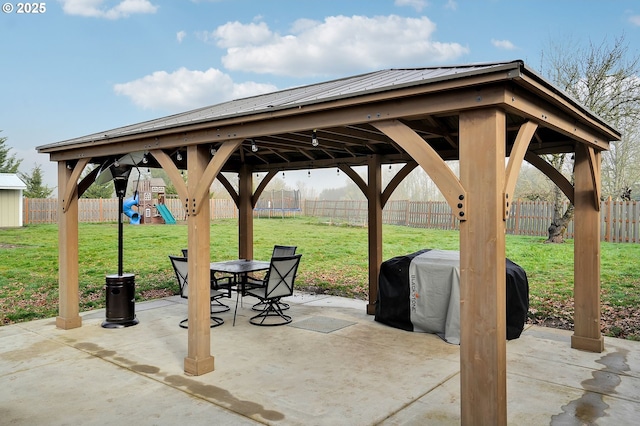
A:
[[542, 35, 640, 242]]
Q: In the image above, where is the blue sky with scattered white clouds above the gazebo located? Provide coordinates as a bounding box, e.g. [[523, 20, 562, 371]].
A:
[[0, 0, 640, 196]]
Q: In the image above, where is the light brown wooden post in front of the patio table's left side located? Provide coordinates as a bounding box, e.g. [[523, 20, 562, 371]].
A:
[[184, 146, 214, 376]]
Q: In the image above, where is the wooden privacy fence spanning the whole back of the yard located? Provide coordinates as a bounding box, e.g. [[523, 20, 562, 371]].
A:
[[23, 197, 640, 243]]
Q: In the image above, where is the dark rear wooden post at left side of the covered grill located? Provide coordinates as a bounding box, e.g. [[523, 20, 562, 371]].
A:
[[366, 155, 382, 315]]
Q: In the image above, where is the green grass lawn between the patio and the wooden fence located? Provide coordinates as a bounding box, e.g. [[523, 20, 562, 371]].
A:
[[0, 217, 640, 340]]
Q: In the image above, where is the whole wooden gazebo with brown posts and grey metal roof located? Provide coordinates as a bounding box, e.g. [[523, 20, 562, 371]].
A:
[[37, 60, 620, 424]]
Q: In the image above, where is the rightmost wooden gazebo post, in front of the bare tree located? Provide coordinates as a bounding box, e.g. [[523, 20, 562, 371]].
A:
[[571, 144, 604, 352]]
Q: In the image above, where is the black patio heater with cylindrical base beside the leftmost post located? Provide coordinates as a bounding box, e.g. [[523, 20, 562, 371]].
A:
[[102, 165, 138, 328]]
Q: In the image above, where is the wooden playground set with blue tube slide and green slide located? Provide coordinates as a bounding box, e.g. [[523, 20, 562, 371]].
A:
[[123, 178, 176, 225]]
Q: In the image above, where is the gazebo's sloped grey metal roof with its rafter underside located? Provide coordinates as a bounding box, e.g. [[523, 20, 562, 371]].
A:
[[37, 61, 612, 172]]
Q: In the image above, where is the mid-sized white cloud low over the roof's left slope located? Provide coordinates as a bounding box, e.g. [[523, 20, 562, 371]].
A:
[[114, 67, 277, 112]]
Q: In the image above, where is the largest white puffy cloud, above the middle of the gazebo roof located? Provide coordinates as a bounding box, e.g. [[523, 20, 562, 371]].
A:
[[208, 15, 469, 76]]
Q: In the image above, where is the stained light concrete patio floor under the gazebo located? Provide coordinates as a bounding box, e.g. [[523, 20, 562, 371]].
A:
[[0, 294, 640, 426]]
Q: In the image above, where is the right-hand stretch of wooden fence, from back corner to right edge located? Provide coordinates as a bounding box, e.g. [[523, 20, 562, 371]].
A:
[[303, 200, 640, 243]]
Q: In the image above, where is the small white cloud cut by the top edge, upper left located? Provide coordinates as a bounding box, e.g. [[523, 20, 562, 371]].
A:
[[59, 0, 158, 19]]
